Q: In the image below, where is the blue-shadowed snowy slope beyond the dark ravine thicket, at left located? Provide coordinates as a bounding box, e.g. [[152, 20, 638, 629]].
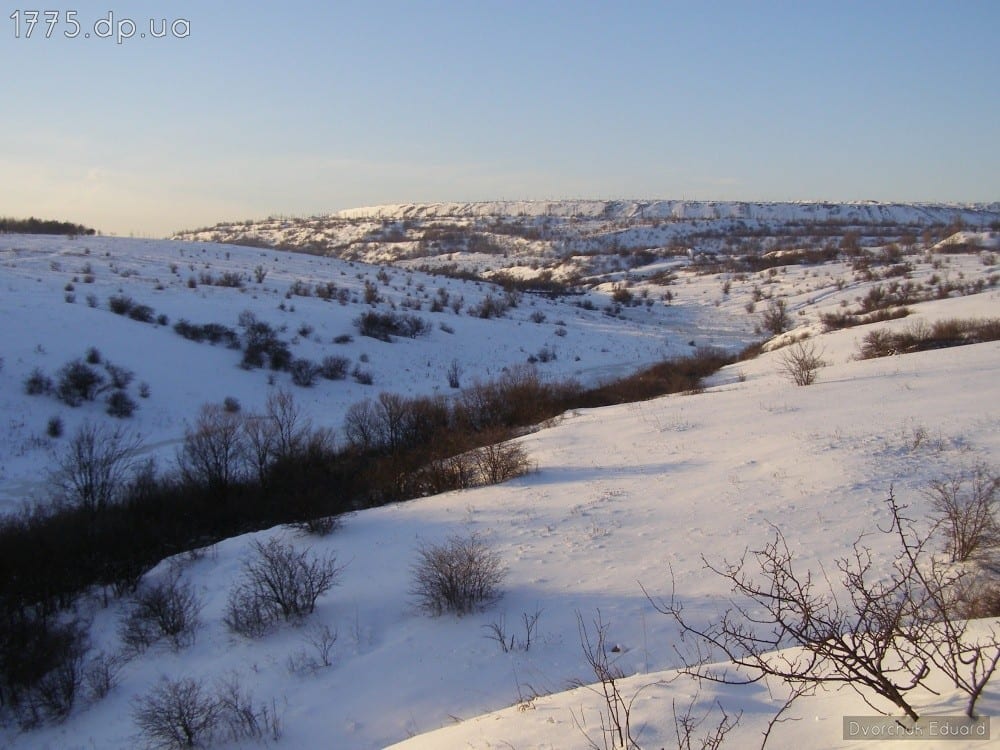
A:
[[0, 235, 753, 507]]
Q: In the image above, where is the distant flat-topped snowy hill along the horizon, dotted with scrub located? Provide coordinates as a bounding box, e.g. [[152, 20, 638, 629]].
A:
[[175, 200, 1000, 281]]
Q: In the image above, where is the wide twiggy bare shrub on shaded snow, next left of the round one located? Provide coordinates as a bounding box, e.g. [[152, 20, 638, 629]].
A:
[[226, 537, 343, 636]]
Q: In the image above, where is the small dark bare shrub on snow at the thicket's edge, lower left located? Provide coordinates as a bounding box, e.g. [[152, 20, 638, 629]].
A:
[[120, 570, 203, 651]]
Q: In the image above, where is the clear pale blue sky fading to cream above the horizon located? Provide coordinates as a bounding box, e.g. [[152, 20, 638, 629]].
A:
[[0, 0, 1000, 236]]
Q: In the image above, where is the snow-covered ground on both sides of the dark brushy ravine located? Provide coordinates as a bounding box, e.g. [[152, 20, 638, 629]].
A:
[[0, 214, 1000, 750]]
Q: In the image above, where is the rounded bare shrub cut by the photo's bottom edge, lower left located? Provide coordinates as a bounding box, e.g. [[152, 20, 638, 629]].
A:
[[132, 677, 222, 750]]
